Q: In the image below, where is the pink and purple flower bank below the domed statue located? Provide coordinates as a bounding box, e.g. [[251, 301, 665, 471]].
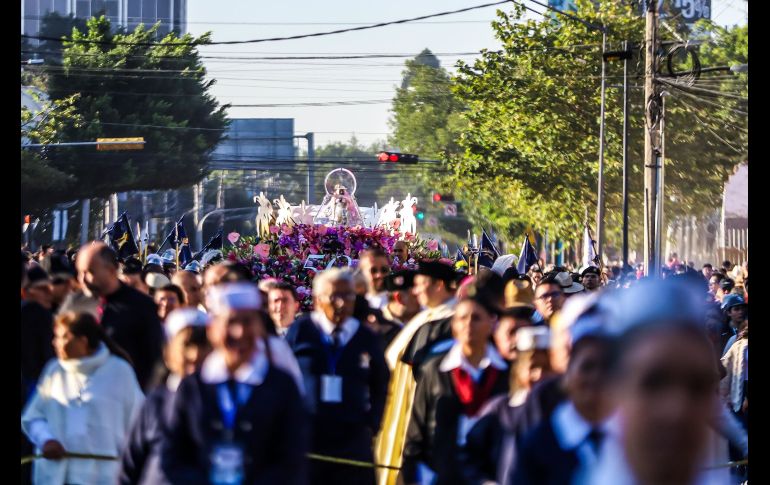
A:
[[225, 224, 441, 311]]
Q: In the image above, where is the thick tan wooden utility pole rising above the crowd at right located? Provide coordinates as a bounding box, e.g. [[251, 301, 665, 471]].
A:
[[644, 0, 661, 276]]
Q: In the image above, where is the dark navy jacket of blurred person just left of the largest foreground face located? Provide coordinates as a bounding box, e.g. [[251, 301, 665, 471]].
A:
[[506, 412, 580, 485]]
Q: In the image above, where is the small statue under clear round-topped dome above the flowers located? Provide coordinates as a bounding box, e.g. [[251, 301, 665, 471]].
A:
[[313, 168, 364, 226]]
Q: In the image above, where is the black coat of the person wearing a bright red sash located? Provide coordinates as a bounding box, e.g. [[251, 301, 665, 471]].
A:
[[401, 355, 508, 484]]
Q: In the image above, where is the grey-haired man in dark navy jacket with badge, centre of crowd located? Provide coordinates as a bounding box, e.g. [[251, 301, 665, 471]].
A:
[[286, 268, 390, 484]]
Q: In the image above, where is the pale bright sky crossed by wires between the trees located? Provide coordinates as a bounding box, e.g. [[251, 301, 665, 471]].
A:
[[187, 0, 747, 146]]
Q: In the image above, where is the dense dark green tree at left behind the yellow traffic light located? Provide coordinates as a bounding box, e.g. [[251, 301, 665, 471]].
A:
[[21, 17, 226, 210]]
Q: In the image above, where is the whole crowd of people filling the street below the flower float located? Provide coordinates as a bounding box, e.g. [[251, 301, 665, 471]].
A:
[[21, 242, 748, 485]]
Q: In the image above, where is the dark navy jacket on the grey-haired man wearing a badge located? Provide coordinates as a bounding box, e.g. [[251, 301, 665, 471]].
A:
[[286, 316, 390, 483]]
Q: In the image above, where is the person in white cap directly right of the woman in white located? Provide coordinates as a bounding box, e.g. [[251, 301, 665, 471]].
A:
[[118, 308, 211, 485]]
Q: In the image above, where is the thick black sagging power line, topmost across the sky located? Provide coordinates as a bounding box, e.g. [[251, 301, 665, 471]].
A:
[[21, 0, 512, 47]]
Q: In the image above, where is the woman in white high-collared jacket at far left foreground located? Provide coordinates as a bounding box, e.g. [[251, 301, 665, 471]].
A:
[[21, 313, 144, 485]]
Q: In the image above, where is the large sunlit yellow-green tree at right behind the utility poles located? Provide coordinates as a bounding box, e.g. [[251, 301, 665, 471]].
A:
[[444, 1, 745, 253]]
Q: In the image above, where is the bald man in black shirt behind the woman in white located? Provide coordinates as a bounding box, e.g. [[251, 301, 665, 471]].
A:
[[76, 242, 163, 389]]
